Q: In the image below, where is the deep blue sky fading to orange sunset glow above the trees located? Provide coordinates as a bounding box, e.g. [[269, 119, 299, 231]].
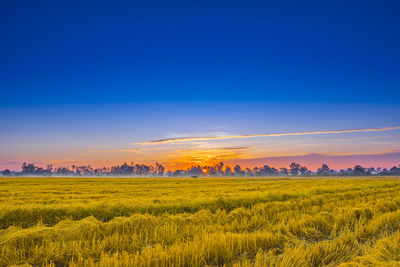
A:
[[0, 1, 400, 170]]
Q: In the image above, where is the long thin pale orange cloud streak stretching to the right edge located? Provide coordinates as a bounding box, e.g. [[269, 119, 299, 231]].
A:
[[136, 126, 400, 145]]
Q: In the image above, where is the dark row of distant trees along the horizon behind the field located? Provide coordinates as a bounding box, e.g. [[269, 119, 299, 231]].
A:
[[2, 162, 400, 177]]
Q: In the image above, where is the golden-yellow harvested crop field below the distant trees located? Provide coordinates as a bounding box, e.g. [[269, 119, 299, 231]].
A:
[[0, 177, 400, 266]]
